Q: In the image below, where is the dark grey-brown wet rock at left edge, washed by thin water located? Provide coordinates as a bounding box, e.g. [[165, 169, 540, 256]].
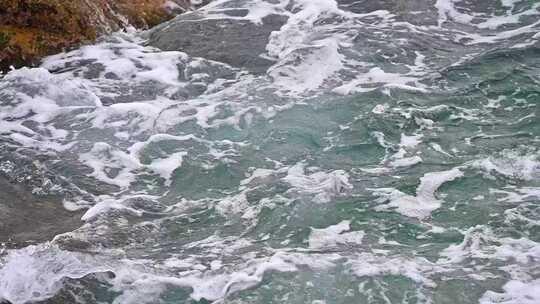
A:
[[0, 147, 95, 248]]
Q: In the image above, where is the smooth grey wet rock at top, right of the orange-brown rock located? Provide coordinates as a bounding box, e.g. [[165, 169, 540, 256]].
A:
[[148, 10, 287, 73]]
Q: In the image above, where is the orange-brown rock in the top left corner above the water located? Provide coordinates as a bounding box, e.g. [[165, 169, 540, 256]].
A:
[[0, 0, 190, 71]]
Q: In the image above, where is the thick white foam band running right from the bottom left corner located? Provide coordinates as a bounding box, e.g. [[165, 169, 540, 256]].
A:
[[0, 245, 296, 304]]
